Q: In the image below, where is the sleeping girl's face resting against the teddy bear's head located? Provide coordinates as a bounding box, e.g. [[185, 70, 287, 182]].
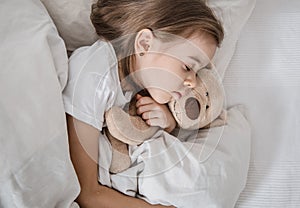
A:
[[135, 29, 216, 104]]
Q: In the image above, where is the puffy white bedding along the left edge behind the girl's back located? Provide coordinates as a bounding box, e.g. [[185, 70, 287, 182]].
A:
[[0, 0, 79, 208]]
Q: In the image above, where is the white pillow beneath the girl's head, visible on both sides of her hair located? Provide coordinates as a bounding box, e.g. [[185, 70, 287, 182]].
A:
[[41, 0, 256, 77]]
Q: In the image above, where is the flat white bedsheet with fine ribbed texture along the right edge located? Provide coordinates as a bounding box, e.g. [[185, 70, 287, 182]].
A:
[[224, 0, 300, 208]]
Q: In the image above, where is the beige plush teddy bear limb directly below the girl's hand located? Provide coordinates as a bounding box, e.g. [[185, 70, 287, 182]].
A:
[[105, 106, 159, 145]]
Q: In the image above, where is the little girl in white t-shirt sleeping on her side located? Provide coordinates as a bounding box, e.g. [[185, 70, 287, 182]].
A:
[[63, 0, 223, 208]]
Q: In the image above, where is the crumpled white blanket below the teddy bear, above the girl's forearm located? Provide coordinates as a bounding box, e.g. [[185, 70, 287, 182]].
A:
[[99, 108, 250, 208]]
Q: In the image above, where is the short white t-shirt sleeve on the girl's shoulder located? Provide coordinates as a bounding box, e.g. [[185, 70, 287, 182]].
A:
[[63, 45, 116, 131]]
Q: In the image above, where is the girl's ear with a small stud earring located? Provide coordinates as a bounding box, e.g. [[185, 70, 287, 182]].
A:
[[134, 29, 154, 55]]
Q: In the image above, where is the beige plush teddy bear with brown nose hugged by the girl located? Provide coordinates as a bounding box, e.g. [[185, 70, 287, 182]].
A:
[[104, 69, 226, 174]]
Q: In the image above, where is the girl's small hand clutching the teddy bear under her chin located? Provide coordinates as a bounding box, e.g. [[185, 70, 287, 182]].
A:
[[136, 94, 176, 133]]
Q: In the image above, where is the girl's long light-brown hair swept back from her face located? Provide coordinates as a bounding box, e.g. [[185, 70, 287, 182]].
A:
[[91, 0, 224, 82]]
